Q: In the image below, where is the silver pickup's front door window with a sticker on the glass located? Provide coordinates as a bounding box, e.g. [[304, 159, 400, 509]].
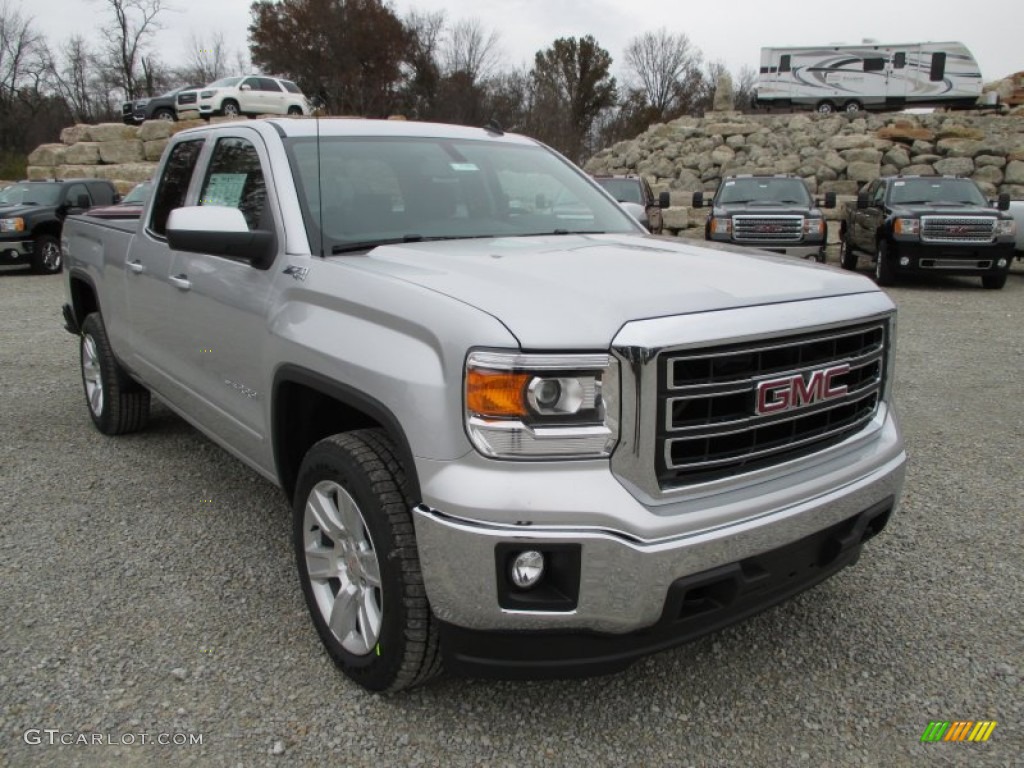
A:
[[199, 138, 270, 229]]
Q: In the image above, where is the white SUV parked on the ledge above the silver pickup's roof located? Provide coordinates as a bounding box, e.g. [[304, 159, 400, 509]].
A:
[[176, 75, 310, 117]]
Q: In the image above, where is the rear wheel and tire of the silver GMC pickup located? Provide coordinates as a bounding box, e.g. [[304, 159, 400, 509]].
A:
[[79, 312, 150, 435]]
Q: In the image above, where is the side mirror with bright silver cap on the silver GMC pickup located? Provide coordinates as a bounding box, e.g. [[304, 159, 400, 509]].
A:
[[167, 206, 278, 269]]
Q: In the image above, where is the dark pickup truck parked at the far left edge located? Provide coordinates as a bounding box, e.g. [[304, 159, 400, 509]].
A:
[[0, 178, 120, 274]]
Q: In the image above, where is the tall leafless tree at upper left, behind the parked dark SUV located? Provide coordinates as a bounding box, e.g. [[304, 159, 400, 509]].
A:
[[93, 0, 164, 99]]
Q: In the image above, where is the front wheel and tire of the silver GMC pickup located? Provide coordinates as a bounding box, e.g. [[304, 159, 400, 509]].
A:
[[293, 429, 441, 691]]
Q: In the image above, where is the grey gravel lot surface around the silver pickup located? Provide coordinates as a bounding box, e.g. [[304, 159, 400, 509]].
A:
[[0, 262, 1024, 768]]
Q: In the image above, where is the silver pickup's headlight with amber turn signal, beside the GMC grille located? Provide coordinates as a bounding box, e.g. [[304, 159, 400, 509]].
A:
[[464, 351, 618, 459]]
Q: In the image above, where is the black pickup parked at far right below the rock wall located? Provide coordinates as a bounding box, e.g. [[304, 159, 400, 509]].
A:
[[840, 176, 1016, 290]]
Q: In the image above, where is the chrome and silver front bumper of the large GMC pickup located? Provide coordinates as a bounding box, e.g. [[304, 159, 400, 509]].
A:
[[413, 416, 906, 634]]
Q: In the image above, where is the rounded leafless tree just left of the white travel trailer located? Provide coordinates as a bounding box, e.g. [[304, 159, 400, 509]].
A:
[[625, 28, 702, 119]]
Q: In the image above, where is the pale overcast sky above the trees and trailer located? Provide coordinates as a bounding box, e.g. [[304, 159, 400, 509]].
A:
[[18, 0, 1024, 82]]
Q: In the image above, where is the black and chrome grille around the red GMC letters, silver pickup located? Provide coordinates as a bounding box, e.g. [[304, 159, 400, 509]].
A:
[[654, 323, 888, 489]]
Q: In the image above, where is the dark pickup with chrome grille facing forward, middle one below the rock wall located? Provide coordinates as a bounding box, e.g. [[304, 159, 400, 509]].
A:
[[693, 174, 836, 263]]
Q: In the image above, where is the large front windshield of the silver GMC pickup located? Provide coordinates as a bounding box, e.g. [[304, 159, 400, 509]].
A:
[[286, 137, 637, 253]]
